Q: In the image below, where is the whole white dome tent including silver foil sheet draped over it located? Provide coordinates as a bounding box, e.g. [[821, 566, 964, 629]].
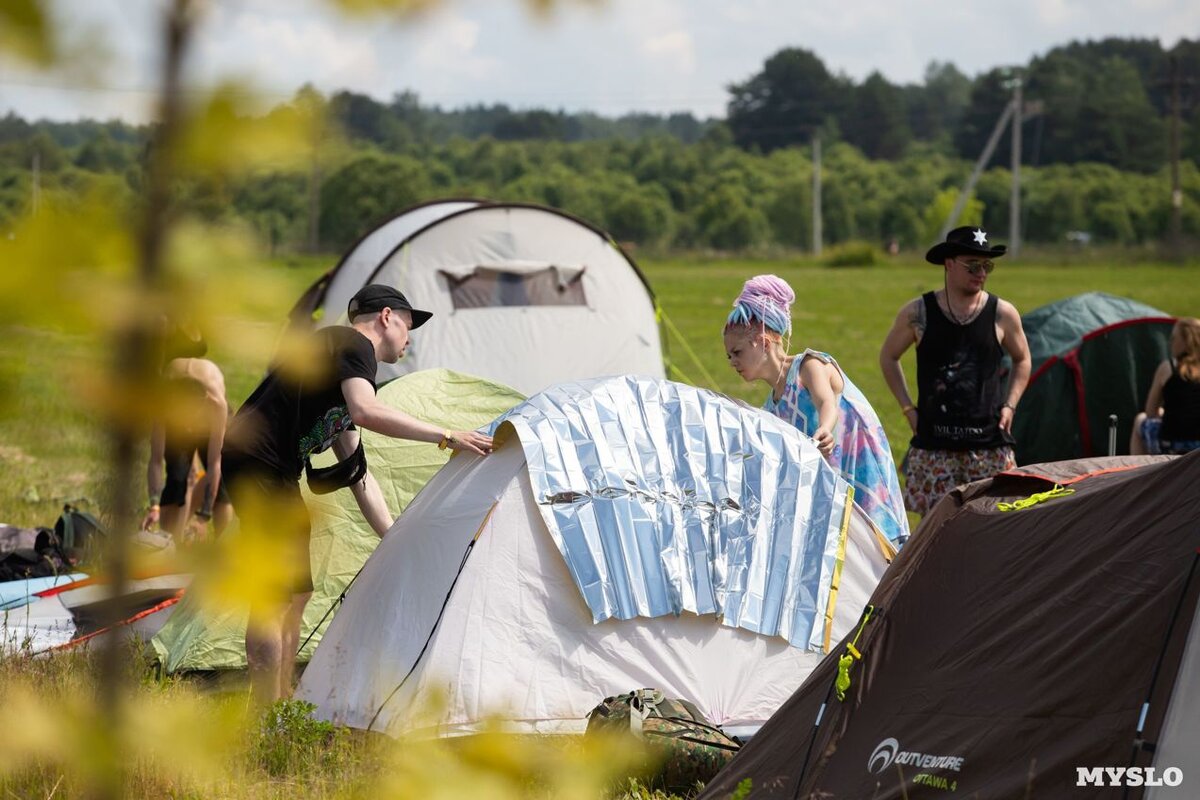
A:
[[298, 377, 892, 735]]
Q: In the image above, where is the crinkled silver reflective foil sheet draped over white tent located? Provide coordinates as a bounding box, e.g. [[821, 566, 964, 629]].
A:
[[492, 377, 850, 650]]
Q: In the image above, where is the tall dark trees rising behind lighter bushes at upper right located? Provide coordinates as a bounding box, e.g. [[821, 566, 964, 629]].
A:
[[727, 38, 1200, 172]]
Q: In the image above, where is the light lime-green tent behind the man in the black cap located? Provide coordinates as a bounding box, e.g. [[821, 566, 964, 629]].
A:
[[151, 369, 524, 673]]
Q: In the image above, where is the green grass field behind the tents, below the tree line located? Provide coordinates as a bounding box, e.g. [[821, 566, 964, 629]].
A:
[[0, 255, 1200, 525]]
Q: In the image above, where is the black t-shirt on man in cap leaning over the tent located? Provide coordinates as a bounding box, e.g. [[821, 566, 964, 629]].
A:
[[222, 326, 378, 481]]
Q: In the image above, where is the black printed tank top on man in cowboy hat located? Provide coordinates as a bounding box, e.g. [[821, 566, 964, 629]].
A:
[[912, 291, 1013, 450]]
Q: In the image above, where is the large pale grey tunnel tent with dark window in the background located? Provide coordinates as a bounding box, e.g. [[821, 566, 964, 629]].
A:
[[293, 200, 665, 395]]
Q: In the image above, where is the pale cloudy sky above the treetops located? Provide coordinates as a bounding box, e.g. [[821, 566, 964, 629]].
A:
[[0, 0, 1200, 121]]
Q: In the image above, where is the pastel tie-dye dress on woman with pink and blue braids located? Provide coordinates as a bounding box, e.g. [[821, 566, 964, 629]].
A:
[[763, 350, 908, 545]]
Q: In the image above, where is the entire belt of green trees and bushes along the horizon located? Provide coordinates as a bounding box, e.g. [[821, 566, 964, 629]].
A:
[[0, 40, 1200, 251]]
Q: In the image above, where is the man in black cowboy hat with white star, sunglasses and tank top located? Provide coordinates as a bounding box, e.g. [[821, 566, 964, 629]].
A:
[[880, 225, 1031, 515]]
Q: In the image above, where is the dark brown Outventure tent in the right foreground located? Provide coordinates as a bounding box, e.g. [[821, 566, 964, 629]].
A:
[[701, 452, 1200, 800]]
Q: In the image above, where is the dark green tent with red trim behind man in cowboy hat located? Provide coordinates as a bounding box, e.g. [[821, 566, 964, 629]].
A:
[[1013, 291, 1175, 464]]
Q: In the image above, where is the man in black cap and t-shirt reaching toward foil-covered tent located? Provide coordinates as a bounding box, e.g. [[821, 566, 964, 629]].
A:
[[222, 284, 492, 703]]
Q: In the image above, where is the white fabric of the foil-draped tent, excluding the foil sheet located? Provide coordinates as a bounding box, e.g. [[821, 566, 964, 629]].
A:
[[296, 381, 887, 735]]
